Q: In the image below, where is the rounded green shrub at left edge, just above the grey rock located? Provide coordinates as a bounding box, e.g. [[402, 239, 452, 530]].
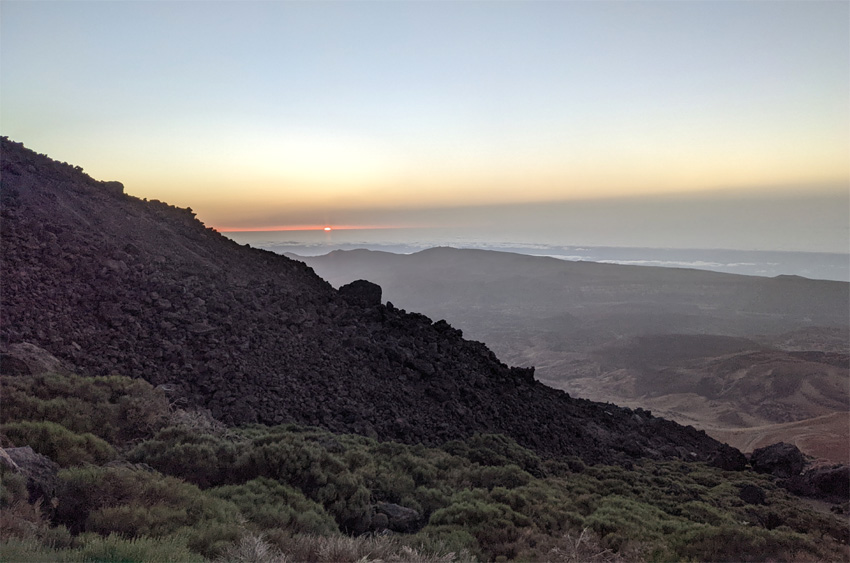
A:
[[0, 421, 116, 467]]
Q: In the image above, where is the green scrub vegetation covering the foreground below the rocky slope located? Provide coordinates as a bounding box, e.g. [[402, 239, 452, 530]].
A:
[[0, 375, 848, 562]]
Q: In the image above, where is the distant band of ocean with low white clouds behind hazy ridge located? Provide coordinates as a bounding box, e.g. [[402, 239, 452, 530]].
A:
[[223, 229, 850, 281]]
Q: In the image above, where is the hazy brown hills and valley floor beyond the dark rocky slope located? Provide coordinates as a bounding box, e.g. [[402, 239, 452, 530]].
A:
[[299, 248, 850, 461]]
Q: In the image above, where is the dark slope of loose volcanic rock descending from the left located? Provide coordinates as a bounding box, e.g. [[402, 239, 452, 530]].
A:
[[0, 139, 740, 470]]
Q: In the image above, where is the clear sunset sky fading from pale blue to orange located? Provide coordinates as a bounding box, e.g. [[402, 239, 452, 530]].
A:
[[0, 0, 850, 252]]
